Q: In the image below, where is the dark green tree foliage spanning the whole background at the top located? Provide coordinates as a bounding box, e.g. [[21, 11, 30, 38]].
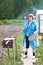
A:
[[0, 0, 43, 19]]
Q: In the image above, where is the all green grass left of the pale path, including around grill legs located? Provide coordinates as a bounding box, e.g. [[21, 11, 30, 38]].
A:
[[0, 33, 23, 65]]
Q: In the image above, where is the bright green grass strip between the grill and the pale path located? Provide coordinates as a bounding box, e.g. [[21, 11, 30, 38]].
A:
[[16, 33, 23, 65]]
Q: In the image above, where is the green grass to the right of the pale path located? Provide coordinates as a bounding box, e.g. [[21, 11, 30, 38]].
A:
[[36, 41, 43, 65]]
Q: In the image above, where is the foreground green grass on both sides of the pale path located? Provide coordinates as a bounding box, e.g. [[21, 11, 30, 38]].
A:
[[0, 32, 43, 65]]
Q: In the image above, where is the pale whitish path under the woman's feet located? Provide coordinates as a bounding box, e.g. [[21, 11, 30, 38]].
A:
[[21, 47, 36, 65]]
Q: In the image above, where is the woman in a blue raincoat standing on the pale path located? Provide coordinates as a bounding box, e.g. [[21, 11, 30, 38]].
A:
[[23, 14, 39, 57]]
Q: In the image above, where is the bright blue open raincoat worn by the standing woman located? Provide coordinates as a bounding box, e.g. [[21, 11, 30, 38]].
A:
[[22, 20, 39, 49]]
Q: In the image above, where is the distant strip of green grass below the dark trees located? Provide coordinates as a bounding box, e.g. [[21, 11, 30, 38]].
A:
[[0, 19, 24, 25]]
